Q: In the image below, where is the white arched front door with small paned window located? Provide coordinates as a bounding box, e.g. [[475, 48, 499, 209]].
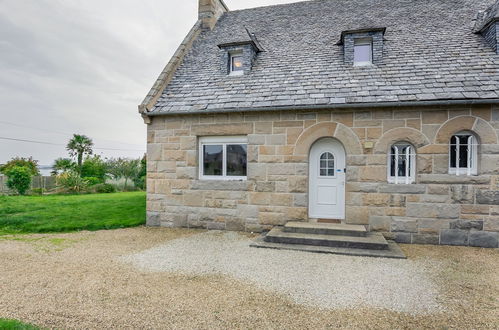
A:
[[308, 138, 346, 219]]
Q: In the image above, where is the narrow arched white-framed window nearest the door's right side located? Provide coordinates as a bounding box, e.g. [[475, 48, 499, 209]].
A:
[[388, 142, 416, 184]]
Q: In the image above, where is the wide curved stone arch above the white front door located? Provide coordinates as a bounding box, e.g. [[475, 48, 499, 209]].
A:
[[294, 122, 362, 156]]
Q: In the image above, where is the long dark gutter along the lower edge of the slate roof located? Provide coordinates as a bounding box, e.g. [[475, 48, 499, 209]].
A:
[[144, 98, 499, 117]]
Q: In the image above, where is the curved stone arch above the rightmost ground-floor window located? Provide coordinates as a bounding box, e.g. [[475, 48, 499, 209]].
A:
[[435, 116, 497, 144]]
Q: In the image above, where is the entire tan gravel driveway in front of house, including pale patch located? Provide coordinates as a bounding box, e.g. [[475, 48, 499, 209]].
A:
[[0, 227, 499, 329]]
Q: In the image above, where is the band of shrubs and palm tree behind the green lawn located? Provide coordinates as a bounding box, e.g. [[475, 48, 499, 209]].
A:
[[0, 134, 146, 195]]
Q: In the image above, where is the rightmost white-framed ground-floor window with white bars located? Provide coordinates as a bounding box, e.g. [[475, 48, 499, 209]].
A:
[[449, 132, 478, 175]]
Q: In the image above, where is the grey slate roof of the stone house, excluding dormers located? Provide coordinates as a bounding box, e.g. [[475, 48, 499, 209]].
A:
[[150, 0, 499, 114]]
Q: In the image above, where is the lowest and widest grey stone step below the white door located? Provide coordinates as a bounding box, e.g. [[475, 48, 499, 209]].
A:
[[250, 235, 407, 259]]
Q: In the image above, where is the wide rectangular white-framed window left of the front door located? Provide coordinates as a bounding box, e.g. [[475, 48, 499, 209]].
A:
[[199, 136, 248, 180]]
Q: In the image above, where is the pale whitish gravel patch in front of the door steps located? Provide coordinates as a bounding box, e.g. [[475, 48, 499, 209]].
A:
[[123, 231, 442, 313]]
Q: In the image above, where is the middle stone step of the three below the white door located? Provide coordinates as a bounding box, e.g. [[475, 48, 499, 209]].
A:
[[265, 227, 388, 250]]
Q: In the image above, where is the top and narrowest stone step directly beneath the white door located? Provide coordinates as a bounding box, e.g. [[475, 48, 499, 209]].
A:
[[283, 221, 367, 237]]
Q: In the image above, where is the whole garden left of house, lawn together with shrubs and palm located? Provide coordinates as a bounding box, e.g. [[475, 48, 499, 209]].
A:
[[0, 135, 146, 236]]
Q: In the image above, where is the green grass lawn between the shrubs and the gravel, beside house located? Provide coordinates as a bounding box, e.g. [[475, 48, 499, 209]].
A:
[[0, 192, 146, 235]]
